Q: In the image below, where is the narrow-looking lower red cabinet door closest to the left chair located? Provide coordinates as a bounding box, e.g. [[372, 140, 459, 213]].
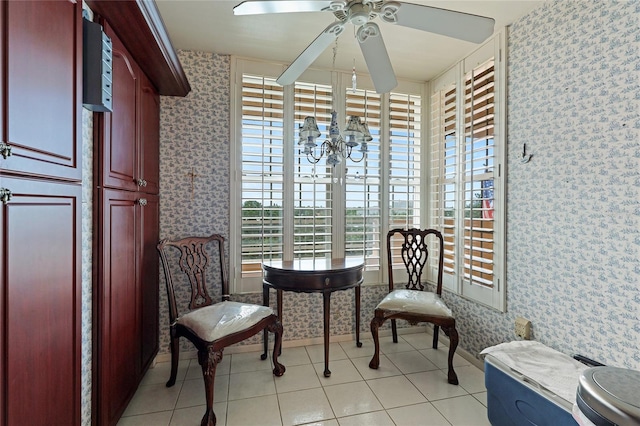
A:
[[139, 194, 160, 371]]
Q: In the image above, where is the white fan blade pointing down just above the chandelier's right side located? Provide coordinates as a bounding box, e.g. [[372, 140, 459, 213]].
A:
[[358, 22, 398, 93]]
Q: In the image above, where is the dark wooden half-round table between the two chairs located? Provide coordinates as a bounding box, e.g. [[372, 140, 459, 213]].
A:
[[262, 258, 364, 377]]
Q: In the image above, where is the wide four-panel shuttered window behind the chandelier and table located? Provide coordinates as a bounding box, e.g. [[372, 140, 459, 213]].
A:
[[231, 59, 425, 292]]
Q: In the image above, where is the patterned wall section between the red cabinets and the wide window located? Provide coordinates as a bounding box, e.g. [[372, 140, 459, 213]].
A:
[[160, 51, 229, 353]]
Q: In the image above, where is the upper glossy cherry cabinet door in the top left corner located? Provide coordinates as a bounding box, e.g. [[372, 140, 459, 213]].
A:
[[0, 0, 82, 181]]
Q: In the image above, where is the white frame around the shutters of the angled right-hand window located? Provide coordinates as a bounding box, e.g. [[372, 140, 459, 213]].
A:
[[428, 30, 507, 312]]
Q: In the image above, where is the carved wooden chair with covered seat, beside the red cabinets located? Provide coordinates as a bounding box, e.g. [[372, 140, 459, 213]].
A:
[[158, 234, 285, 425]]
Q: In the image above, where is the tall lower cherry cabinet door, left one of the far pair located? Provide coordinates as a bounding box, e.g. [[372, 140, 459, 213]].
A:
[[93, 189, 140, 425]]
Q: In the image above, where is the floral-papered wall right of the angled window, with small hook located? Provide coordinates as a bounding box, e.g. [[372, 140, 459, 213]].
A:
[[442, 0, 640, 369]]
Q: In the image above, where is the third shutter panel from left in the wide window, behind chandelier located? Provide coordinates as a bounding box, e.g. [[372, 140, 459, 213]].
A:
[[345, 89, 382, 271]]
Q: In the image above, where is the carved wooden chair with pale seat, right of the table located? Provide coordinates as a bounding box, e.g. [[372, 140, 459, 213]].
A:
[[369, 229, 458, 385]]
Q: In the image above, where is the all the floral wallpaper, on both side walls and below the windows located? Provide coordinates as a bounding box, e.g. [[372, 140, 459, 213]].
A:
[[160, 0, 640, 369]]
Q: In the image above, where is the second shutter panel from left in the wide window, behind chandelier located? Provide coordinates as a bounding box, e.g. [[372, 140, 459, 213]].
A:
[[293, 83, 333, 259]]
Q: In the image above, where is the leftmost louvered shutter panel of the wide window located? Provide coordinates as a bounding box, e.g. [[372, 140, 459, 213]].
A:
[[240, 75, 284, 277]]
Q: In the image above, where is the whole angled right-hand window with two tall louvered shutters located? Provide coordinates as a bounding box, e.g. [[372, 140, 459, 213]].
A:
[[430, 35, 506, 310]]
